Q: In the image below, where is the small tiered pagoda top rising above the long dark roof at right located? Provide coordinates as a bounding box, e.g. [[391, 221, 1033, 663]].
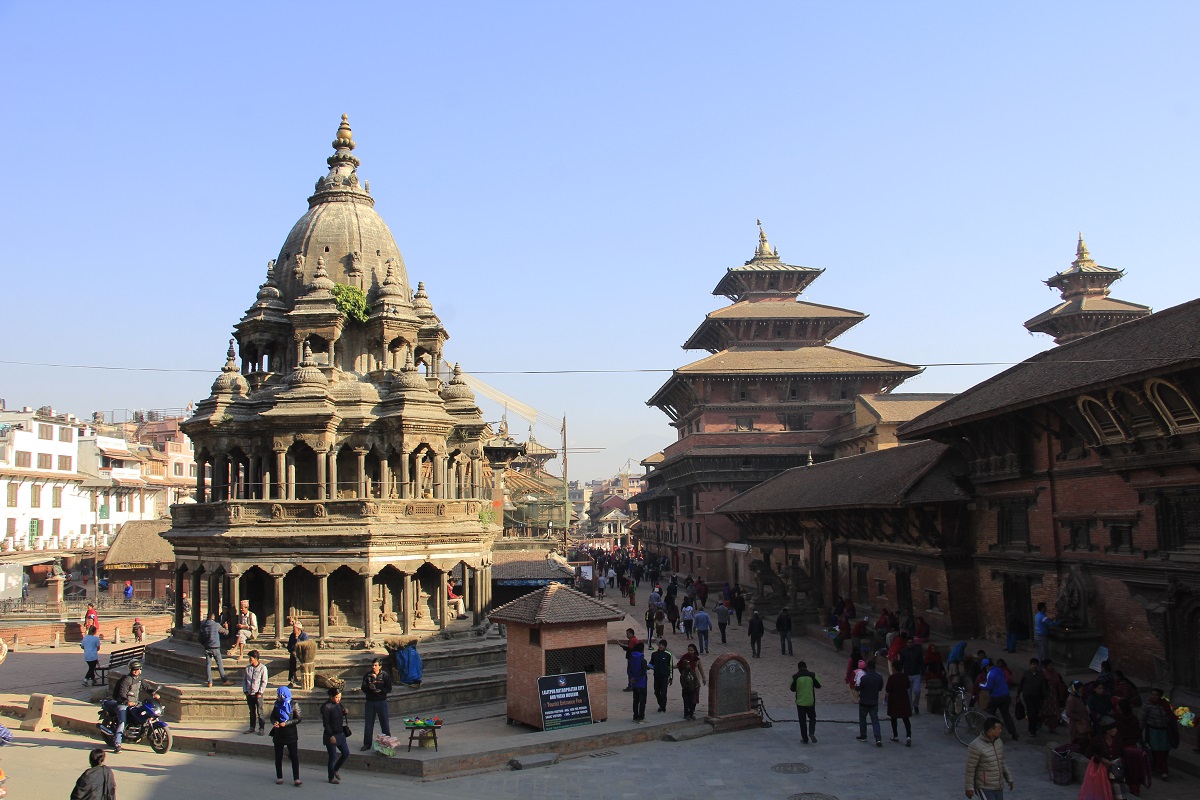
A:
[[1025, 234, 1150, 344]]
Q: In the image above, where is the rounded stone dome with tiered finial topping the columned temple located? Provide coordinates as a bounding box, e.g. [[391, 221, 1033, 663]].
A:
[[275, 114, 408, 307]]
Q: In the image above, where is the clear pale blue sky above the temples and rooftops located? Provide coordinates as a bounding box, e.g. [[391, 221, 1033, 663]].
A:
[[0, 1, 1200, 479]]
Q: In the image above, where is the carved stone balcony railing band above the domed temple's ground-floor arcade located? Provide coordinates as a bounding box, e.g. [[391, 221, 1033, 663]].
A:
[[170, 499, 484, 528]]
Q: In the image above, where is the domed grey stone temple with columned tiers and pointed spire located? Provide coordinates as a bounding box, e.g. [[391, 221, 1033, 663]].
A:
[[166, 115, 492, 644]]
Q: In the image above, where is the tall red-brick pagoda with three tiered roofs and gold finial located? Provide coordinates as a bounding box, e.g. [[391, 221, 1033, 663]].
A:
[[630, 223, 920, 581]]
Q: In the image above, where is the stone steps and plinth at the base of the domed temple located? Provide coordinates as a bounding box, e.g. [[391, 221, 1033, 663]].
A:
[[145, 637, 508, 722]]
